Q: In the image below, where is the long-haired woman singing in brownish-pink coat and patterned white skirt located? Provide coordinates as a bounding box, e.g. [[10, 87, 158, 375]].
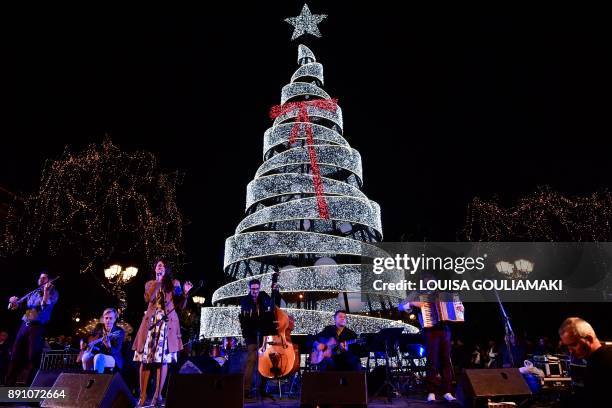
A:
[[132, 259, 193, 406]]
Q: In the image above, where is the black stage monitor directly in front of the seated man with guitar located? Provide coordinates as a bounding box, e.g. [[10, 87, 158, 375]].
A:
[[300, 371, 368, 407]]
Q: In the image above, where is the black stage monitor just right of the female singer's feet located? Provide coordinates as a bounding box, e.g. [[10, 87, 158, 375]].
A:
[[166, 374, 244, 408]]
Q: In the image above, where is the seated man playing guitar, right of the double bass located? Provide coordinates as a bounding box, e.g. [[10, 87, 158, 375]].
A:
[[313, 310, 361, 371]]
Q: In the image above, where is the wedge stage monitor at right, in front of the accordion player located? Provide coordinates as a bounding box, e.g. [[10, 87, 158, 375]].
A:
[[457, 368, 531, 407]]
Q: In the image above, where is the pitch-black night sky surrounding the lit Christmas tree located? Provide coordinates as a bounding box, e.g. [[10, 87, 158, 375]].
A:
[[0, 1, 612, 339]]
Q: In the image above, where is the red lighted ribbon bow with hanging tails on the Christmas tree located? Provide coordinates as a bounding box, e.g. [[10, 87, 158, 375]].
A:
[[270, 98, 338, 220]]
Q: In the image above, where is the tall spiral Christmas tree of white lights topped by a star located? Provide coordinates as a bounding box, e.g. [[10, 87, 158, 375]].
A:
[[201, 6, 416, 337]]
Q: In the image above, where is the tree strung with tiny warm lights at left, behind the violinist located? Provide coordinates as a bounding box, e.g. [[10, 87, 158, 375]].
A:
[[0, 138, 185, 292]]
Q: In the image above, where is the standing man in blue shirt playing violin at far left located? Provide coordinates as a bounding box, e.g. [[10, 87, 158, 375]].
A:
[[6, 270, 58, 386]]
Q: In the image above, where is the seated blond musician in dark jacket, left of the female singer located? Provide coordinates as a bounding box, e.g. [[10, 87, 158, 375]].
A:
[[81, 308, 125, 373]]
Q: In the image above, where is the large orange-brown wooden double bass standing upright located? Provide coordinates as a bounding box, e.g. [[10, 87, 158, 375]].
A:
[[258, 272, 300, 379]]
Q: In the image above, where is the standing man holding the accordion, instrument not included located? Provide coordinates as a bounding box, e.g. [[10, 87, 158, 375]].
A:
[[399, 288, 463, 402]]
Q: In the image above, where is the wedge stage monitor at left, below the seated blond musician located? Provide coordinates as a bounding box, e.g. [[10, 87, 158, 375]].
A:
[[40, 373, 134, 408]]
